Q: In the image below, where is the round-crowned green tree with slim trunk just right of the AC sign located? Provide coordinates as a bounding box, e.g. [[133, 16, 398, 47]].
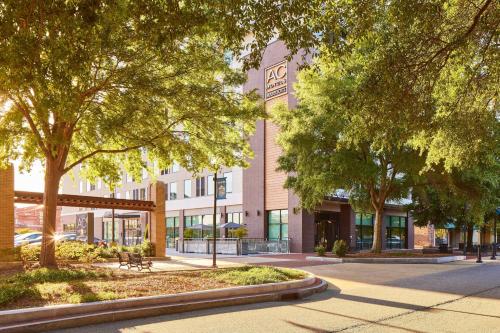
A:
[[275, 50, 423, 252]]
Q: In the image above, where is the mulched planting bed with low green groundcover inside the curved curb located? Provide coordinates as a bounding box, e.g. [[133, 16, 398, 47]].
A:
[[0, 265, 304, 310]]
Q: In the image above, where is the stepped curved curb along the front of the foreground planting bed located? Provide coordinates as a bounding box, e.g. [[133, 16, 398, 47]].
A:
[[0, 276, 327, 333]]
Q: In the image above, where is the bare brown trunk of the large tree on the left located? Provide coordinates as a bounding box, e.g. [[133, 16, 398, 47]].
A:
[[40, 157, 62, 267]]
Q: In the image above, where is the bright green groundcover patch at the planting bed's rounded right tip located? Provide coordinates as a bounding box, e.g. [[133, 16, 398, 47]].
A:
[[204, 266, 305, 285]]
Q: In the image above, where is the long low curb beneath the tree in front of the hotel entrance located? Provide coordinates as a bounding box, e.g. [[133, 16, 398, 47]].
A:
[[306, 256, 465, 264]]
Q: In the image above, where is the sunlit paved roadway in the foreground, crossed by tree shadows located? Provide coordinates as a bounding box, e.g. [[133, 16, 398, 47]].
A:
[[50, 261, 500, 333]]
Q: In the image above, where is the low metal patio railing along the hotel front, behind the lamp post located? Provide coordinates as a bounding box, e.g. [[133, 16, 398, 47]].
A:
[[177, 238, 290, 255]]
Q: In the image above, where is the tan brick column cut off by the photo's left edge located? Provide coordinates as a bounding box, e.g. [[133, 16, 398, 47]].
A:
[[0, 166, 14, 253]]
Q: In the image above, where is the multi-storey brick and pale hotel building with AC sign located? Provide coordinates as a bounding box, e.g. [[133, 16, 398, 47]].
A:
[[62, 41, 414, 252]]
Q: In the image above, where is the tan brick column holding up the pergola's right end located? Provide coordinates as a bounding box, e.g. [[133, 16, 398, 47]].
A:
[[150, 181, 167, 257]]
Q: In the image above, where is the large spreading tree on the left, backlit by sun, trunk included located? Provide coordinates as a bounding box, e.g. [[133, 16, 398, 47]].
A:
[[0, 0, 268, 266]]
